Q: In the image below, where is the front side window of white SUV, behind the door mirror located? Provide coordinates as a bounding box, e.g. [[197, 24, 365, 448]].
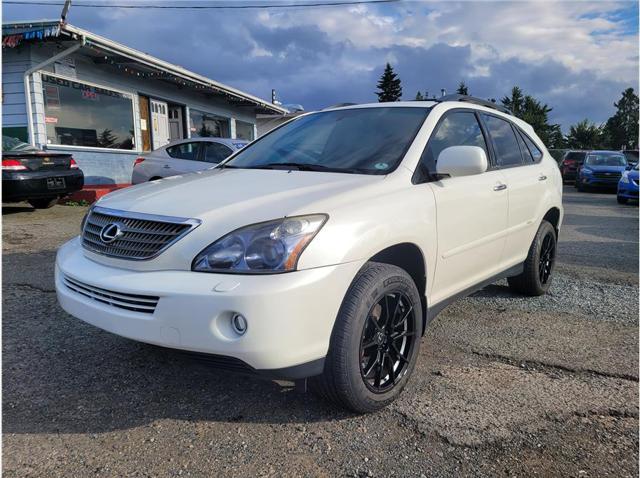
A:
[[421, 111, 487, 173]]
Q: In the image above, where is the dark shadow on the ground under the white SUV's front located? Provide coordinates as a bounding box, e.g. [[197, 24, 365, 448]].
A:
[[2, 285, 353, 434]]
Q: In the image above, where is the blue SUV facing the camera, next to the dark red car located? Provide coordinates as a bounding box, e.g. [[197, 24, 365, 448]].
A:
[[576, 151, 628, 191]]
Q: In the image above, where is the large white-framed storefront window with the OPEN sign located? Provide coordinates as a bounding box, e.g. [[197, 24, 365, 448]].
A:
[[42, 74, 134, 149]]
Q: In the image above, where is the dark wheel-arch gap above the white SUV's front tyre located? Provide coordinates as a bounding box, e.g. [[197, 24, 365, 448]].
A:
[[369, 242, 427, 334]]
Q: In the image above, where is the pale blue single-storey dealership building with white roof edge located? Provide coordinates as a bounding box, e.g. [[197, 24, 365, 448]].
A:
[[2, 20, 286, 189]]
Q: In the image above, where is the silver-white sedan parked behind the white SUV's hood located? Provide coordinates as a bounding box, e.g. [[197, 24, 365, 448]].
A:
[[131, 138, 248, 184]]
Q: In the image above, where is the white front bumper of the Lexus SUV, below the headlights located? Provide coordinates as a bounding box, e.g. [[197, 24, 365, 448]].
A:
[[55, 238, 362, 379]]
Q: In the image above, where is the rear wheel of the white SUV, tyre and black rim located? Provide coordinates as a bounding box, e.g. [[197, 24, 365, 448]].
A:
[[507, 221, 557, 296]]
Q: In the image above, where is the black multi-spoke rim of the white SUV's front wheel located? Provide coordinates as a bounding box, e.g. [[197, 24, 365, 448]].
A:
[[360, 292, 416, 393]]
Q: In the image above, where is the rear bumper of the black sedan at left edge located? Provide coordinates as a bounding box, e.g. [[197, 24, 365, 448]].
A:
[[2, 169, 84, 201]]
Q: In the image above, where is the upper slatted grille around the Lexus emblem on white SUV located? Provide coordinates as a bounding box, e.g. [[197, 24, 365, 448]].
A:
[[82, 206, 200, 260]]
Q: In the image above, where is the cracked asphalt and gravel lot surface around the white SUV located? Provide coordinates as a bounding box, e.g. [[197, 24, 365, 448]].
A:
[[2, 188, 638, 477]]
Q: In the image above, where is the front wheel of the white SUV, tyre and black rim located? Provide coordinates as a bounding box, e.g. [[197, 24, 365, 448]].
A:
[[310, 262, 422, 413]]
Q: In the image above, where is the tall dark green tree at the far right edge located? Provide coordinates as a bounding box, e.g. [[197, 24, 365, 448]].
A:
[[603, 88, 638, 149]]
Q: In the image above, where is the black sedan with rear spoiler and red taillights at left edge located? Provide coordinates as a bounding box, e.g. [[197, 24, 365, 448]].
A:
[[2, 136, 84, 209]]
